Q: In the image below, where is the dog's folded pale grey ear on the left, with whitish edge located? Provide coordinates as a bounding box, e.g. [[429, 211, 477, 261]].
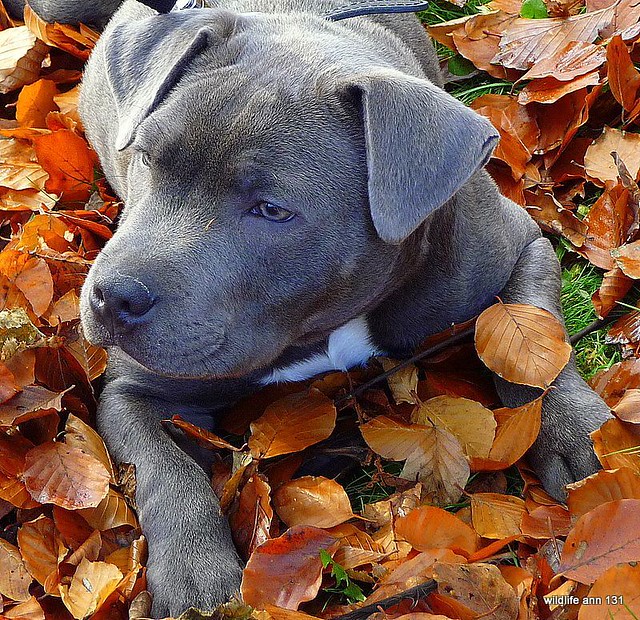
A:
[[102, 9, 240, 151]]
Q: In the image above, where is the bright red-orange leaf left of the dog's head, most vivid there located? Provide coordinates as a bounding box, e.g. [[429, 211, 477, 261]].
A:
[[33, 129, 95, 202]]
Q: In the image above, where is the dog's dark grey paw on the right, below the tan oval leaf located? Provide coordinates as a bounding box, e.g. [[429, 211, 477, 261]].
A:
[[527, 384, 611, 501]]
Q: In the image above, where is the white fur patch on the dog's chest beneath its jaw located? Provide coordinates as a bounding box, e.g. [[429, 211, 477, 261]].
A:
[[260, 316, 384, 385]]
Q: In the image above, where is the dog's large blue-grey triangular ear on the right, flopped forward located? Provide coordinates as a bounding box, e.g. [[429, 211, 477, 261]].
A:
[[347, 69, 498, 243]]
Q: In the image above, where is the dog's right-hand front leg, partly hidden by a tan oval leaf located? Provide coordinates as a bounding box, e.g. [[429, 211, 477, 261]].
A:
[[496, 238, 610, 499]]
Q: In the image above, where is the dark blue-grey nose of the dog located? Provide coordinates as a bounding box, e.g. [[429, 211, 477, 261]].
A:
[[90, 276, 156, 335]]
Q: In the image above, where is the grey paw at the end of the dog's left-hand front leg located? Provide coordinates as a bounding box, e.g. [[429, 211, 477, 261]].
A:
[[147, 536, 242, 618]]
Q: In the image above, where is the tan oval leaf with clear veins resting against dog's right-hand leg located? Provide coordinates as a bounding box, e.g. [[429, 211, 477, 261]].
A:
[[475, 303, 571, 388]]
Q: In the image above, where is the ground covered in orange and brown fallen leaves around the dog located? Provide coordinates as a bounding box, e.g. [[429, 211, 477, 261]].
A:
[[0, 0, 640, 620]]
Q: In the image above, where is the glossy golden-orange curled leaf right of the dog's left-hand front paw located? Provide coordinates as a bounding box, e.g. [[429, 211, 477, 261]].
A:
[[273, 476, 354, 528]]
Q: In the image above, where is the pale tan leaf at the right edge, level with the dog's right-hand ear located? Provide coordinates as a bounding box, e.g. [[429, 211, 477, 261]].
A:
[[584, 127, 640, 186]]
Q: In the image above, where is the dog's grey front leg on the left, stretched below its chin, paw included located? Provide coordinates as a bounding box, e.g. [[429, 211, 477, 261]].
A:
[[98, 378, 242, 617]]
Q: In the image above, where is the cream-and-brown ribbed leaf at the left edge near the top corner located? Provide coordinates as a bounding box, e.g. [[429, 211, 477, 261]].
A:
[[0, 26, 49, 93]]
